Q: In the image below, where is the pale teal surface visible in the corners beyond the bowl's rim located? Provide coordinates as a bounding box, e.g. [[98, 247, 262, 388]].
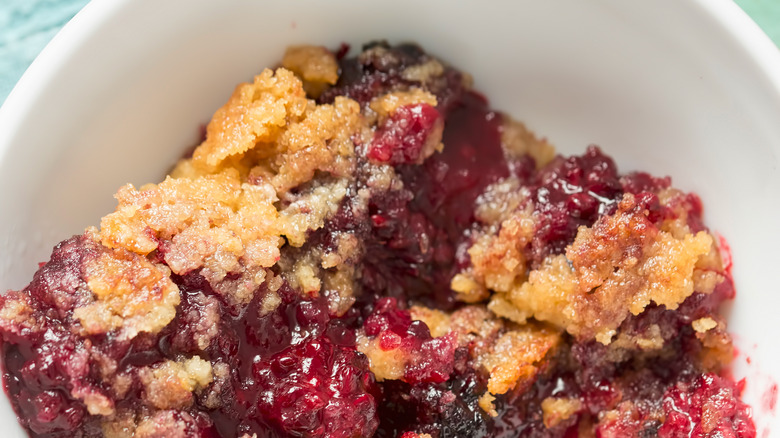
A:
[[0, 0, 780, 103]]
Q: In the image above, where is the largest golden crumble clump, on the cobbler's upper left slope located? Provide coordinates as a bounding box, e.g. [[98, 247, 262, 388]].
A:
[[100, 63, 370, 304]]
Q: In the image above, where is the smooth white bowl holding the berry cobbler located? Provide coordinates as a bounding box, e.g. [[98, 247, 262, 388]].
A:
[[0, 0, 780, 437]]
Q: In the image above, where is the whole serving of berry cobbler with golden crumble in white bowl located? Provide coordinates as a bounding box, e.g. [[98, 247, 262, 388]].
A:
[[0, 43, 756, 438]]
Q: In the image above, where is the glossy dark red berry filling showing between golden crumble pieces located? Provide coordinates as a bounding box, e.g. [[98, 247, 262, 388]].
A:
[[0, 44, 755, 438]]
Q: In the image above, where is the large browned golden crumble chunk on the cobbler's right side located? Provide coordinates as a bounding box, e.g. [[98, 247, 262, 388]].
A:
[[490, 194, 712, 344]]
